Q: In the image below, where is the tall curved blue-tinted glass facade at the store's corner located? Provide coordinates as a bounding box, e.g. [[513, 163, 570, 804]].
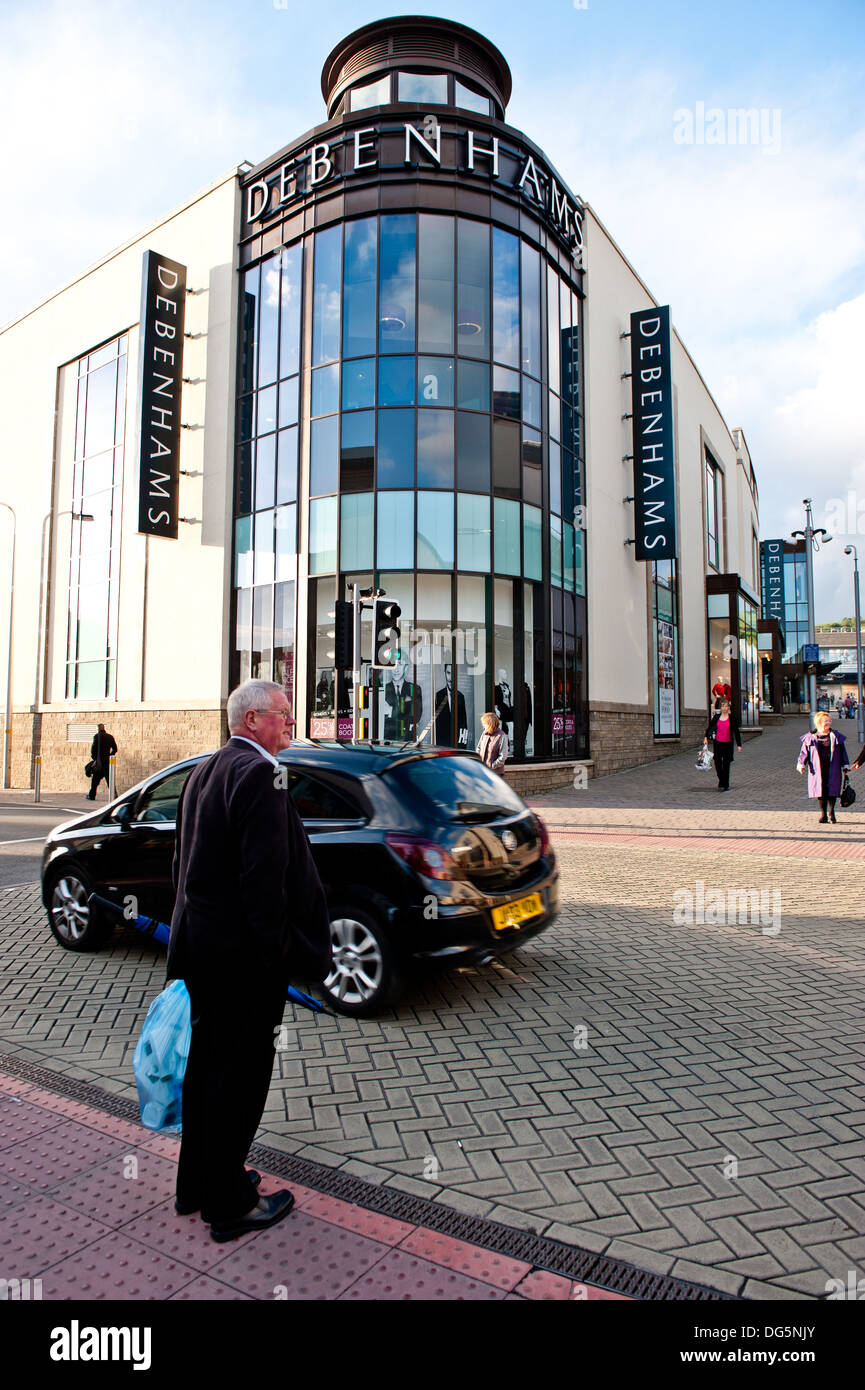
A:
[[231, 126, 588, 760]]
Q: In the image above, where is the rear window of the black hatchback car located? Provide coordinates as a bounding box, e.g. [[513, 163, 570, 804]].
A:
[[384, 758, 526, 823]]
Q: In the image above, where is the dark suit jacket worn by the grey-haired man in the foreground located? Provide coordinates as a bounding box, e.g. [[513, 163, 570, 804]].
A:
[[167, 739, 331, 983]]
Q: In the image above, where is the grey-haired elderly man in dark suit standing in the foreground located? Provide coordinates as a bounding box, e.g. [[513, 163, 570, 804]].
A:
[[167, 680, 331, 1240]]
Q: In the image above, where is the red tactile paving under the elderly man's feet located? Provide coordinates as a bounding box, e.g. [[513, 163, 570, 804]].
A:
[[0, 1073, 636, 1302]]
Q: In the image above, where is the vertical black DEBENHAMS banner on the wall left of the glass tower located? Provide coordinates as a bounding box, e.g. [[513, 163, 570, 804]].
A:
[[138, 252, 186, 541]]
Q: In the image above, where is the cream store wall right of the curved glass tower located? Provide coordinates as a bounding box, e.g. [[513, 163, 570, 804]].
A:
[[583, 207, 757, 773]]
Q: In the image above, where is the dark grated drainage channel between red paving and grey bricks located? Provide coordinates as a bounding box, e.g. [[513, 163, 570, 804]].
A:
[[0, 1054, 740, 1302]]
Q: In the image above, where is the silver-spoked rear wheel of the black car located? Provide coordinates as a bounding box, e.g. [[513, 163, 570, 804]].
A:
[[321, 905, 403, 1017]]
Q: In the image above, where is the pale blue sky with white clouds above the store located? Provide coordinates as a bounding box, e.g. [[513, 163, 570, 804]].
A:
[[0, 0, 865, 620]]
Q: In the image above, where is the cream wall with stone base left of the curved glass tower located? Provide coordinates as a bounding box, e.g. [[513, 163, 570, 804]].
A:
[[0, 170, 239, 790]]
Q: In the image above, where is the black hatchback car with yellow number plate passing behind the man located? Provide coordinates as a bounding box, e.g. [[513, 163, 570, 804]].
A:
[[42, 742, 559, 1015]]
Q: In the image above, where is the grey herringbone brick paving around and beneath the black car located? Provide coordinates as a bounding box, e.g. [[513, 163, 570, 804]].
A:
[[0, 721, 865, 1298]]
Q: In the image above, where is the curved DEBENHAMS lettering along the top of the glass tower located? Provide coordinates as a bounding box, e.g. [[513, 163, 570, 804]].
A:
[[245, 118, 583, 267]]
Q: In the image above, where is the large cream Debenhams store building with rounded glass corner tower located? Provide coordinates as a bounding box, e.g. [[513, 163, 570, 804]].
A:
[[0, 18, 759, 790]]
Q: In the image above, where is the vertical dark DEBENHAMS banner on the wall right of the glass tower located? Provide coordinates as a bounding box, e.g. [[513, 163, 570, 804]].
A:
[[631, 304, 676, 560]]
